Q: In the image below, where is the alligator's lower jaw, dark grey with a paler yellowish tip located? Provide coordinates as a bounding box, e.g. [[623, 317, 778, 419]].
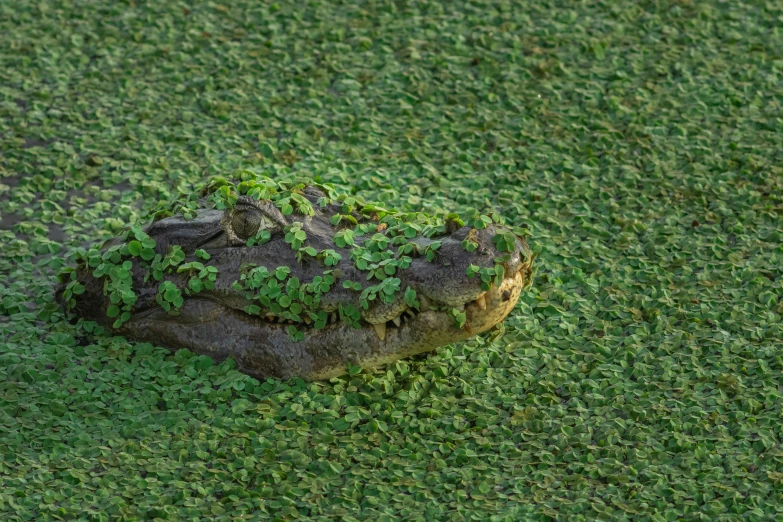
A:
[[122, 264, 529, 380]]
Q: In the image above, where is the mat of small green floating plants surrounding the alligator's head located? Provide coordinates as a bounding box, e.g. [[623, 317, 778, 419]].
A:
[[0, 0, 783, 521]]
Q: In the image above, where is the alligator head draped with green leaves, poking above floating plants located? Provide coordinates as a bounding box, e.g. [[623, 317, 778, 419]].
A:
[[56, 171, 534, 380]]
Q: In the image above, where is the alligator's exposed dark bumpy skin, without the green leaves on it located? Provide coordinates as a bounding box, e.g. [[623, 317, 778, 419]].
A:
[[58, 175, 532, 380]]
